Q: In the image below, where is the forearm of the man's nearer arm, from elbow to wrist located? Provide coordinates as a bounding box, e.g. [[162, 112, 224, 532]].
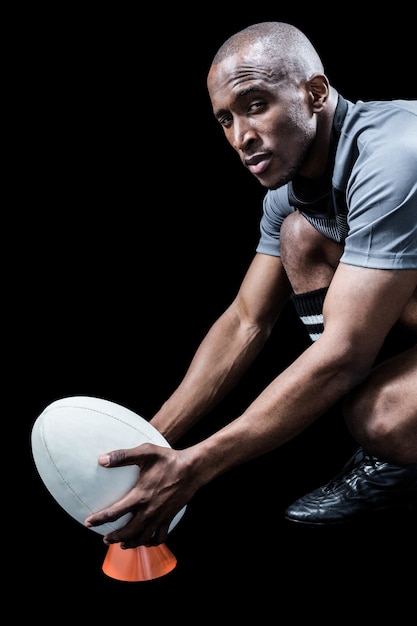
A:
[[189, 336, 365, 486]]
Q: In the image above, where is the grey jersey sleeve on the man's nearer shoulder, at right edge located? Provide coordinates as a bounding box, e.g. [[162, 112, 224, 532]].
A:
[[341, 101, 417, 269]]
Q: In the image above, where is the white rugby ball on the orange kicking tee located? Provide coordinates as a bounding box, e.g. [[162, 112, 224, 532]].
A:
[[31, 396, 186, 535]]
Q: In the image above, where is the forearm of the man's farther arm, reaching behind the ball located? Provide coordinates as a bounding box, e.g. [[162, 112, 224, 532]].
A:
[[151, 307, 270, 445]]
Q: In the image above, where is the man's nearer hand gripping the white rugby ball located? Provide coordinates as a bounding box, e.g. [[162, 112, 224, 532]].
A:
[[85, 443, 196, 549]]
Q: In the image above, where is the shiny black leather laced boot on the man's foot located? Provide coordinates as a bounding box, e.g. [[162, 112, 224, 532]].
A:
[[285, 448, 417, 526]]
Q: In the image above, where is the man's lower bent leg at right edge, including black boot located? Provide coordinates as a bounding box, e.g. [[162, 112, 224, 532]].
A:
[[285, 346, 417, 526]]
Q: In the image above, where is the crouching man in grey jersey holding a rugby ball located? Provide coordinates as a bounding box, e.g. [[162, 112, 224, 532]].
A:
[[86, 22, 417, 548]]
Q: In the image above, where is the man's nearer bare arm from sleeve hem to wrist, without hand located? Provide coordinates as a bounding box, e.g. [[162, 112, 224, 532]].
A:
[[189, 263, 417, 484]]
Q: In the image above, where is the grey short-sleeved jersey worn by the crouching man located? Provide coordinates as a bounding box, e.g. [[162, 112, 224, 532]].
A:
[[256, 98, 417, 269]]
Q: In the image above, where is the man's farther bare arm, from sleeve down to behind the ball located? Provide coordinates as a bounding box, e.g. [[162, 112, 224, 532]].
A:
[[151, 254, 290, 445]]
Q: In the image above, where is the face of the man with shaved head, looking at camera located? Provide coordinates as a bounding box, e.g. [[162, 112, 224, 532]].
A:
[[207, 51, 316, 189]]
